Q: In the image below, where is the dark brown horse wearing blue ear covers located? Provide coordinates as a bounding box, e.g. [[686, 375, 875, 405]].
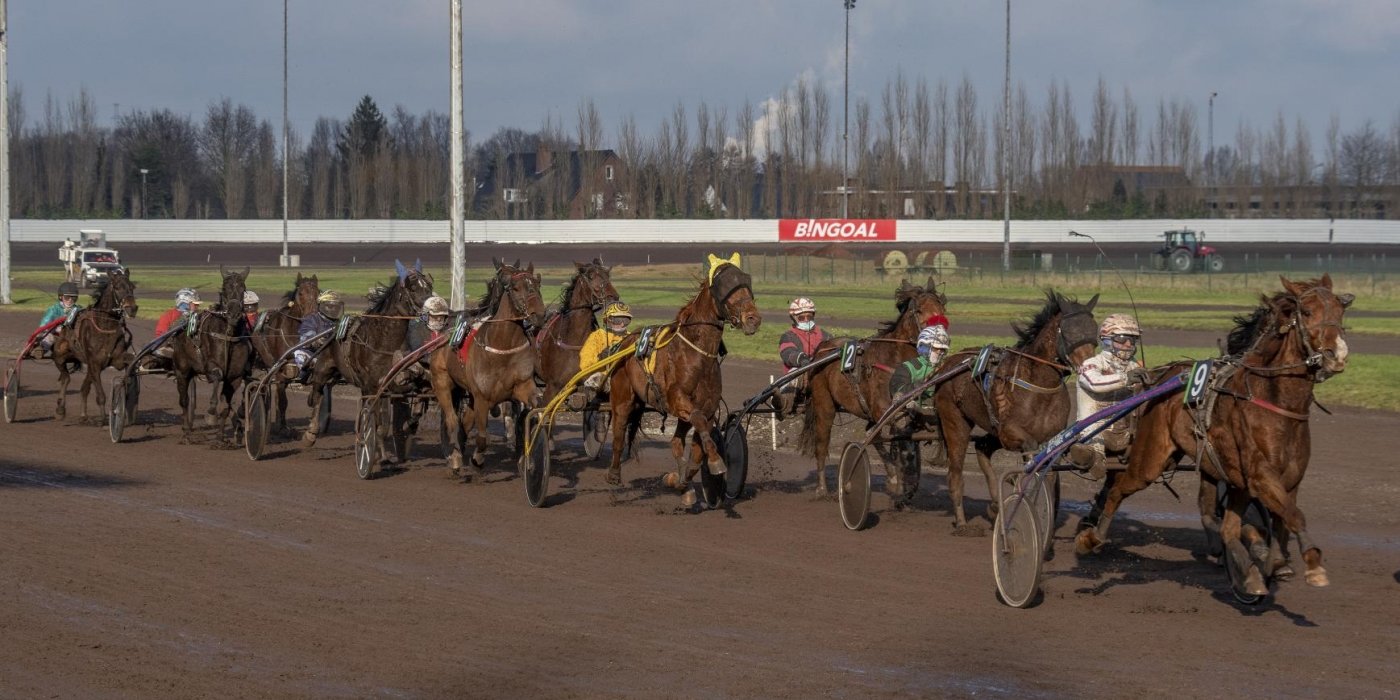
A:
[[301, 260, 433, 461]]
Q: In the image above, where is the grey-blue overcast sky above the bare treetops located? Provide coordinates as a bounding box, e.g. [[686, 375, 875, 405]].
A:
[[8, 0, 1400, 155]]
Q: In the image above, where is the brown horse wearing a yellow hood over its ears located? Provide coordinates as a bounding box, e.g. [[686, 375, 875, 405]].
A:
[[608, 255, 762, 498]]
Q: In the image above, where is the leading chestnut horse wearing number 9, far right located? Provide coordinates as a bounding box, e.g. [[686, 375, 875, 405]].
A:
[[1075, 274, 1355, 595]]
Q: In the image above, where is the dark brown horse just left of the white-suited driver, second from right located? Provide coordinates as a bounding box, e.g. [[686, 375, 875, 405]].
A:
[[934, 290, 1099, 528]]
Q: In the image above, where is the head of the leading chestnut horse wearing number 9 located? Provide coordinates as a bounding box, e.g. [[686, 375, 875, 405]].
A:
[[1270, 273, 1357, 382]]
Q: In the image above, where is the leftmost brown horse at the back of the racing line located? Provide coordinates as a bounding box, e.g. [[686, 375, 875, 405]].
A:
[[53, 270, 136, 421]]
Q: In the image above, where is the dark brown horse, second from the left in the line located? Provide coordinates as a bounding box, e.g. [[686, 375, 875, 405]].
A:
[[171, 266, 252, 442]]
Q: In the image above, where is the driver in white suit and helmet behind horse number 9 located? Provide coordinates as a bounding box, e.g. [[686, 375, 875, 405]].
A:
[[1070, 314, 1148, 479]]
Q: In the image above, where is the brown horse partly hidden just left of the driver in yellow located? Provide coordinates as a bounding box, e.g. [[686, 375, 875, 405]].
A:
[[535, 258, 617, 402]]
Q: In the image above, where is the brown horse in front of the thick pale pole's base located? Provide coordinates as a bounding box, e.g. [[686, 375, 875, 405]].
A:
[[428, 259, 546, 476]]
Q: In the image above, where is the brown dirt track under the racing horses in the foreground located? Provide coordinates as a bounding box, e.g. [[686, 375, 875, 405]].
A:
[[0, 314, 1400, 699]]
